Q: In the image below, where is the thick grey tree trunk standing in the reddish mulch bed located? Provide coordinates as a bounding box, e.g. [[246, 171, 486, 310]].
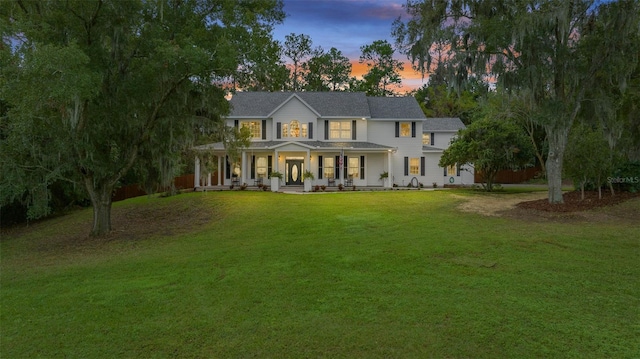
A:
[[545, 126, 569, 204]]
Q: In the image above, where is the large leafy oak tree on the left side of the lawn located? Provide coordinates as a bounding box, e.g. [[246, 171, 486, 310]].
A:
[[0, 0, 284, 235]]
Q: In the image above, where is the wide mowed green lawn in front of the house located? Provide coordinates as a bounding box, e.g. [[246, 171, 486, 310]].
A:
[[0, 191, 640, 358]]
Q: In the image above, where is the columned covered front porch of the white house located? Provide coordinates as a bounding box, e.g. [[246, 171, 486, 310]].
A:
[[194, 141, 395, 191]]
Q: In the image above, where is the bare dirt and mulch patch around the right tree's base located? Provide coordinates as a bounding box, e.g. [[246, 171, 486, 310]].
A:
[[458, 191, 640, 223]]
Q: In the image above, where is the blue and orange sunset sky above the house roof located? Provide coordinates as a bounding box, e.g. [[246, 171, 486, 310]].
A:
[[274, 0, 423, 92]]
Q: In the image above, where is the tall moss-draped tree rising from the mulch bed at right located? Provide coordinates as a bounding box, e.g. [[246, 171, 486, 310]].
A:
[[394, 0, 640, 203]]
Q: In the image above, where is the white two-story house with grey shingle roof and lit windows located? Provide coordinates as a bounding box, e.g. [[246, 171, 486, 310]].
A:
[[195, 92, 473, 187]]
